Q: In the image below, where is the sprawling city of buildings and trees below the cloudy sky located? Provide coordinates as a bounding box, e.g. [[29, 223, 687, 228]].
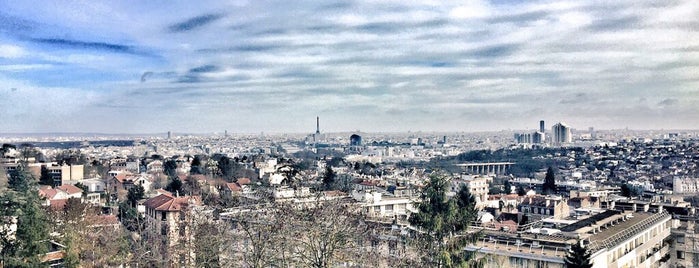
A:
[[0, 119, 699, 268]]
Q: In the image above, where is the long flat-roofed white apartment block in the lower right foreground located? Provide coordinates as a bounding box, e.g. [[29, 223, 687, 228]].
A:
[[466, 210, 673, 268]]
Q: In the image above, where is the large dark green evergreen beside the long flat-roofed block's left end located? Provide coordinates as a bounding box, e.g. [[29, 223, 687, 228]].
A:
[[409, 176, 483, 267]]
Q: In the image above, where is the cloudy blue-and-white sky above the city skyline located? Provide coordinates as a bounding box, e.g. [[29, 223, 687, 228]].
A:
[[0, 0, 699, 133]]
